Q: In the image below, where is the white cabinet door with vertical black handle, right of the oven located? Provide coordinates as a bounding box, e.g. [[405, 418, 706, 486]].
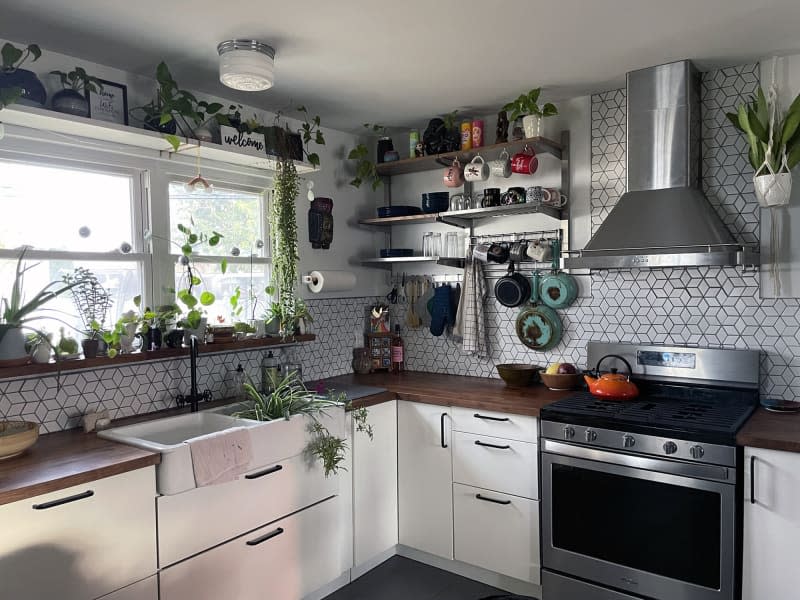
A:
[[742, 448, 800, 600]]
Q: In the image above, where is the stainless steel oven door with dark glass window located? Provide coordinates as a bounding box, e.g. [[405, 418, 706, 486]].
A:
[[542, 440, 736, 600]]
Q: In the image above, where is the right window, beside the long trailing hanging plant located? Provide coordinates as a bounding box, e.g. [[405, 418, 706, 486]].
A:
[[169, 181, 269, 324]]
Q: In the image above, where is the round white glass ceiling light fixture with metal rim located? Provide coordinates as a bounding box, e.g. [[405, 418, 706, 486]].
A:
[[217, 40, 275, 92]]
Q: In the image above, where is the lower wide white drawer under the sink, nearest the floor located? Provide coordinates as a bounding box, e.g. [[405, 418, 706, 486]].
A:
[[159, 498, 343, 600]]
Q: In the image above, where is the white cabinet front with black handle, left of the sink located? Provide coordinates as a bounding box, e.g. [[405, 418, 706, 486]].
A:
[[0, 467, 156, 600]]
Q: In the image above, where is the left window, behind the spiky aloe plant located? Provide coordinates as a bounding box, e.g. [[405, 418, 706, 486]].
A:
[[0, 155, 149, 339]]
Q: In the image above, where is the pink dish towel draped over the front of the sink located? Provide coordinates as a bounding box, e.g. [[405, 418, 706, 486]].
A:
[[186, 427, 253, 487]]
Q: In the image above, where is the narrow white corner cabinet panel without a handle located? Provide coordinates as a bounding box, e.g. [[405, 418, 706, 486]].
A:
[[352, 400, 398, 566]]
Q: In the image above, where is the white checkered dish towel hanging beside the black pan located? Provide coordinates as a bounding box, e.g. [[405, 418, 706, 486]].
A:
[[453, 258, 489, 358]]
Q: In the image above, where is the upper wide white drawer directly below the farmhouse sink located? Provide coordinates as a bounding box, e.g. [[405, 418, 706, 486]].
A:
[[157, 455, 338, 568]]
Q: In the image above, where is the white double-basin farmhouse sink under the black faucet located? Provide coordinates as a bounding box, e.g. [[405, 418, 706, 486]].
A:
[[97, 405, 344, 495]]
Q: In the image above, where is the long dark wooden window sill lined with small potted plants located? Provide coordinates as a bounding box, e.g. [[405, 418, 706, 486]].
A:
[[0, 334, 317, 380]]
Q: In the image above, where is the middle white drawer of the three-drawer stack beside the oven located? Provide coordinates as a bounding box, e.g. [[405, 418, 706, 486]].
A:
[[453, 431, 539, 499]]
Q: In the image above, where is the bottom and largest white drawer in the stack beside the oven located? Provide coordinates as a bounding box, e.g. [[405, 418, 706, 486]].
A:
[[453, 483, 541, 585]]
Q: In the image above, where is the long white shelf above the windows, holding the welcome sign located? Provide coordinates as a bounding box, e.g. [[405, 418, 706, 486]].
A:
[[0, 104, 316, 173]]
